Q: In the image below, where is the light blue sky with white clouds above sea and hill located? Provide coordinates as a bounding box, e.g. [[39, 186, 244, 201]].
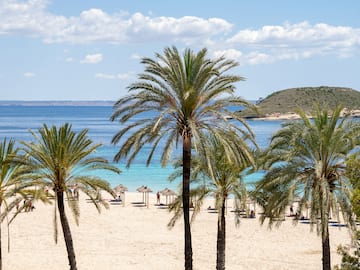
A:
[[0, 0, 360, 100]]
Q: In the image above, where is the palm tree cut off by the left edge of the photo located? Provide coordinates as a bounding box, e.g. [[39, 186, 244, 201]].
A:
[[0, 138, 36, 269]]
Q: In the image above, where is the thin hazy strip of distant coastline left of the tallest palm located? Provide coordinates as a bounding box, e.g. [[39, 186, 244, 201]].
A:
[[0, 100, 115, 106]]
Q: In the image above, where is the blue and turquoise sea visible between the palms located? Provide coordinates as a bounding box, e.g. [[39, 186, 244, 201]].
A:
[[0, 102, 283, 192]]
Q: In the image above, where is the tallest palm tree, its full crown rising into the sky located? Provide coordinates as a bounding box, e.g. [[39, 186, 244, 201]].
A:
[[111, 47, 255, 270]]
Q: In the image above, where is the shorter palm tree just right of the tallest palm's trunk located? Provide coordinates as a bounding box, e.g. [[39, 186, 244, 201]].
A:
[[169, 137, 256, 270]]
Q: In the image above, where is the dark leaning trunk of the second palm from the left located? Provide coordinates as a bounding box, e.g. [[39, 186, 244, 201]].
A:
[[56, 191, 77, 270]]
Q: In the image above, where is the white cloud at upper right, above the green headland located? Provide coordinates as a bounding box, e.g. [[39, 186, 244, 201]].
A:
[[226, 21, 360, 64]]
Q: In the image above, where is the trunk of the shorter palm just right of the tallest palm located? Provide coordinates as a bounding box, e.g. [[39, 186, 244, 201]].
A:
[[216, 198, 226, 270]]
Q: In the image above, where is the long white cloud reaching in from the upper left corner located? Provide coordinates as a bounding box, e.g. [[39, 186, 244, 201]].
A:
[[0, 0, 232, 43]]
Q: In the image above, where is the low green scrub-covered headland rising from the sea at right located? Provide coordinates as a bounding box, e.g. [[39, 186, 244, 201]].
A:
[[243, 86, 360, 117]]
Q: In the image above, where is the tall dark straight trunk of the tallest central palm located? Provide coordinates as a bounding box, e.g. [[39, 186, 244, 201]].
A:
[[182, 136, 192, 270]]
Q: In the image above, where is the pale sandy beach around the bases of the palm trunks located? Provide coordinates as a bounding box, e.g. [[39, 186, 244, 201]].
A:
[[2, 193, 350, 270]]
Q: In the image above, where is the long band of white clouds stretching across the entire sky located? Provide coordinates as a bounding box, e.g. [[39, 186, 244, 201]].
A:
[[0, 0, 360, 65]]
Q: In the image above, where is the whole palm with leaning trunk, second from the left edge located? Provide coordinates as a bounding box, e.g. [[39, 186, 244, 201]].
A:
[[22, 123, 120, 270]]
